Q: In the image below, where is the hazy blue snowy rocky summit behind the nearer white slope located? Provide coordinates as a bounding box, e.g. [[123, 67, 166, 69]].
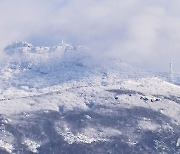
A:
[[0, 42, 149, 88]]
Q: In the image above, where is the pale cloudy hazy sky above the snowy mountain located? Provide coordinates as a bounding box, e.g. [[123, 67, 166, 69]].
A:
[[0, 0, 180, 72]]
